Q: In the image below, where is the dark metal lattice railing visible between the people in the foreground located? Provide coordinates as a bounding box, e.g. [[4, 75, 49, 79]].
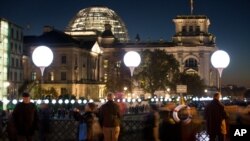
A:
[[0, 114, 208, 141]]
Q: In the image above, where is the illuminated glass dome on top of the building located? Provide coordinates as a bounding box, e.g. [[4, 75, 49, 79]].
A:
[[66, 6, 128, 42]]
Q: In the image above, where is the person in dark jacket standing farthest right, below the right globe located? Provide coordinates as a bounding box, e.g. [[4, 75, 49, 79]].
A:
[[205, 92, 228, 141]]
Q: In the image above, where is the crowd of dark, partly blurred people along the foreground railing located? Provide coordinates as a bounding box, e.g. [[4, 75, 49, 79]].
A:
[[0, 93, 248, 141]]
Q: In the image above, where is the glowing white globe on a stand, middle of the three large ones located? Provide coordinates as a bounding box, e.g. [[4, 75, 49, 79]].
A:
[[123, 51, 141, 92]]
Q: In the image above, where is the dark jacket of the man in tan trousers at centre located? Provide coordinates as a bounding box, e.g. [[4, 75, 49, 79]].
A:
[[99, 100, 121, 127]]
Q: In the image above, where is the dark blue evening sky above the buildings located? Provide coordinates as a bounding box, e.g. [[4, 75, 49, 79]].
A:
[[0, 0, 250, 88]]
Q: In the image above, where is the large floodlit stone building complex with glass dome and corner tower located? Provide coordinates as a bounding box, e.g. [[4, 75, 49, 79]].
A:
[[21, 6, 218, 98]]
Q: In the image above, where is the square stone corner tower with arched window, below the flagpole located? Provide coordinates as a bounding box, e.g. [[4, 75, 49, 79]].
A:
[[172, 15, 217, 86]]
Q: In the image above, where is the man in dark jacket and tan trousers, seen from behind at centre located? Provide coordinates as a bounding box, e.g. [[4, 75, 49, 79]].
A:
[[99, 93, 121, 141]]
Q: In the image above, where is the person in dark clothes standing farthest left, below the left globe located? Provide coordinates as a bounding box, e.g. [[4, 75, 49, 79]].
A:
[[13, 93, 39, 141]]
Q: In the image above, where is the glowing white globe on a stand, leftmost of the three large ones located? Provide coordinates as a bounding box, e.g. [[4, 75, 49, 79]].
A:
[[32, 46, 53, 98]]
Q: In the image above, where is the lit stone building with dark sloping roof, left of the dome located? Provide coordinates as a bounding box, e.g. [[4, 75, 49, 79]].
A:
[[24, 26, 104, 98]]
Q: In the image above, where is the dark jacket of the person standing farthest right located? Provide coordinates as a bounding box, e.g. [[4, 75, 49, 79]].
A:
[[205, 99, 227, 134]]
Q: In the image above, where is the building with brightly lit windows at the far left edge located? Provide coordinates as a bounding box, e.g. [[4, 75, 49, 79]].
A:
[[0, 18, 23, 99]]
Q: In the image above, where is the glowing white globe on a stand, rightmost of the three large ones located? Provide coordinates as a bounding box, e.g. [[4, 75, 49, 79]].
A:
[[211, 50, 230, 93]]
